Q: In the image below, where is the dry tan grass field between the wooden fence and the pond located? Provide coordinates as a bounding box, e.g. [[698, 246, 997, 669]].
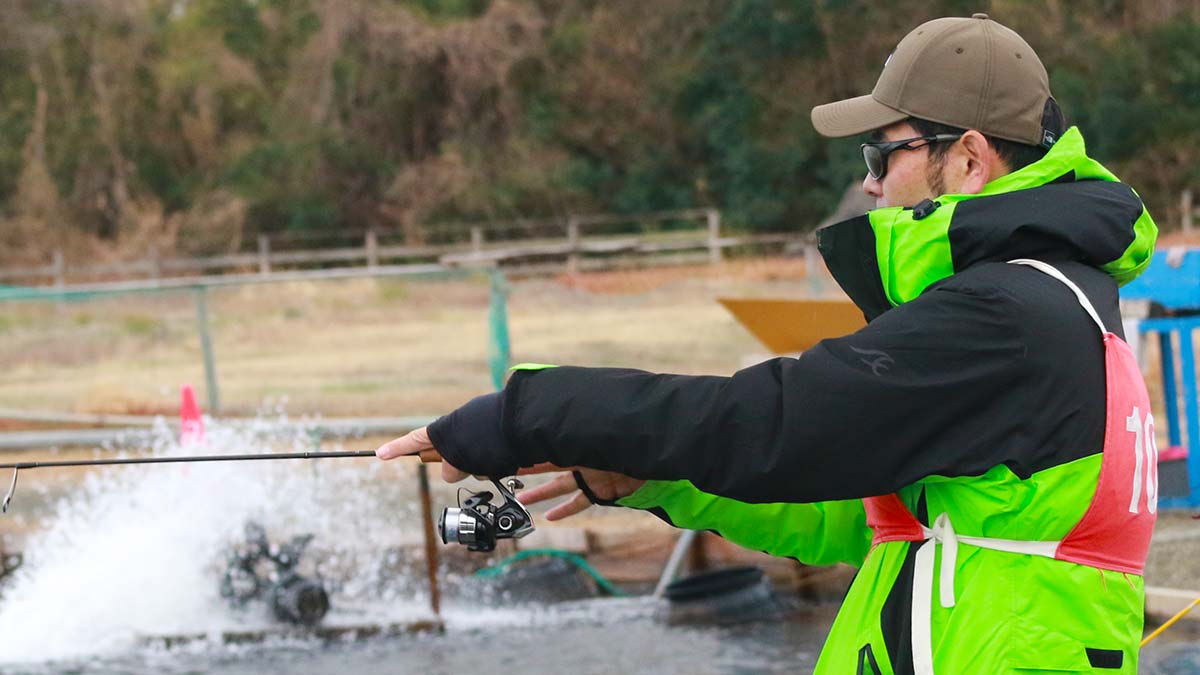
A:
[[0, 259, 833, 416]]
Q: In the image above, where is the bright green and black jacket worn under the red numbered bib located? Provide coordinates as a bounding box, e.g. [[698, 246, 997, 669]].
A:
[[431, 129, 1157, 673]]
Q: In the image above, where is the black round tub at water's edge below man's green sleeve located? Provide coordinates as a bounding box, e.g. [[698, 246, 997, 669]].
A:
[[658, 567, 788, 625]]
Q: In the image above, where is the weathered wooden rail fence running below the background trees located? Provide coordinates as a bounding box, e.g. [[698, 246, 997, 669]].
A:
[[0, 209, 805, 286]]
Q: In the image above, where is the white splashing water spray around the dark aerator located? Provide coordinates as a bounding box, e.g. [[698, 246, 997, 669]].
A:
[[0, 418, 428, 663]]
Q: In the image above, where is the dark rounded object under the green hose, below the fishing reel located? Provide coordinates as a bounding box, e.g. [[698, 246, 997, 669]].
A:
[[463, 557, 600, 604]]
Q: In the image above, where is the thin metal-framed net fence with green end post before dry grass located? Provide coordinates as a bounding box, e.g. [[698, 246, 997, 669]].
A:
[[0, 265, 509, 422]]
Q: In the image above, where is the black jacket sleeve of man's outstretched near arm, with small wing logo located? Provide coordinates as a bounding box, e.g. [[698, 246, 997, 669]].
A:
[[492, 263, 1118, 502]]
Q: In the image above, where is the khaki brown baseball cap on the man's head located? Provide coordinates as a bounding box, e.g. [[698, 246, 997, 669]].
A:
[[812, 14, 1057, 145]]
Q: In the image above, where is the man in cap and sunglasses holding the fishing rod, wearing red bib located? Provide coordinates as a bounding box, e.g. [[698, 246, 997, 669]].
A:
[[379, 14, 1157, 675]]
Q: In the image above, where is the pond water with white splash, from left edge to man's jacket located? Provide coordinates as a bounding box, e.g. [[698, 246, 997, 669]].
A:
[[0, 417, 832, 675]]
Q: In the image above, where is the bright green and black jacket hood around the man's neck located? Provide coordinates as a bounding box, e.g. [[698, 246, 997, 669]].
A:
[[817, 127, 1158, 321]]
